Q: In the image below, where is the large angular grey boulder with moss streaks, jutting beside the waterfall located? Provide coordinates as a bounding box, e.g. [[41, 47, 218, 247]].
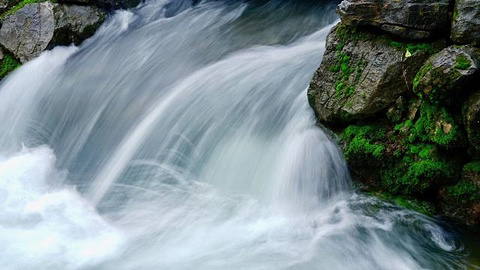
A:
[[308, 24, 428, 123]]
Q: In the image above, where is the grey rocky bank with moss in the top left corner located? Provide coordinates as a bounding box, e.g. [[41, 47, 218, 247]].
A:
[[0, 0, 140, 80]]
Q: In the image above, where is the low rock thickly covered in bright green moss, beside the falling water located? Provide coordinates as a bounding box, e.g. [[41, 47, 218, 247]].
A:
[[340, 120, 458, 196]]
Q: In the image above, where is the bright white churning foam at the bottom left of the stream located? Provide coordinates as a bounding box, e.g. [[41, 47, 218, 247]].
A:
[[0, 147, 122, 269]]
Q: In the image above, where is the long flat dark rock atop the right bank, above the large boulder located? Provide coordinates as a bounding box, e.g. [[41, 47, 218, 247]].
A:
[[337, 0, 450, 39]]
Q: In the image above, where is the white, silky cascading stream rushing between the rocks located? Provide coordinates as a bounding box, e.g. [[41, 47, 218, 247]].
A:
[[0, 1, 474, 270]]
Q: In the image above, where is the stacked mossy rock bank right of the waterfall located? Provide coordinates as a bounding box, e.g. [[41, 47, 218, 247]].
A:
[[308, 0, 480, 225]]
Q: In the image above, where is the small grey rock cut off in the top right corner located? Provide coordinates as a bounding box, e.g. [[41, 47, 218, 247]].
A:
[[451, 0, 480, 45]]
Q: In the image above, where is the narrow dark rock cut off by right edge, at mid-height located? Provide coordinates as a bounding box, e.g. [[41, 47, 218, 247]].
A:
[[463, 91, 480, 151]]
